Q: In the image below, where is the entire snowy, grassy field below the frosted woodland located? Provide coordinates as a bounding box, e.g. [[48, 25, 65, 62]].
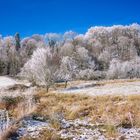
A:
[[0, 76, 140, 140]]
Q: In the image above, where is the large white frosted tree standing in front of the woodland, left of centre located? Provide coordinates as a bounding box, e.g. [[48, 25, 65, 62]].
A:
[[20, 48, 58, 91]]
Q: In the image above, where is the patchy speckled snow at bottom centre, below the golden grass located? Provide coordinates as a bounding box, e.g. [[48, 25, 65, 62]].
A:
[[59, 118, 106, 140]]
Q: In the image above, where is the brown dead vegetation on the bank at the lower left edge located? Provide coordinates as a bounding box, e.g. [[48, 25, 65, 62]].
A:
[[0, 96, 36, 140]]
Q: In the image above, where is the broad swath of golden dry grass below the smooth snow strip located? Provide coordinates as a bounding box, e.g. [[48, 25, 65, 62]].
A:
[[35, 91, 140, 137]]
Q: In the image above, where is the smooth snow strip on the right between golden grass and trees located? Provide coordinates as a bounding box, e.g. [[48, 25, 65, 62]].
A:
[[58, 80, 140, 96]]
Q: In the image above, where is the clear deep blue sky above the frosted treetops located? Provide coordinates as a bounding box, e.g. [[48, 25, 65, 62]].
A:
[[0, 0, 140, 37]]
